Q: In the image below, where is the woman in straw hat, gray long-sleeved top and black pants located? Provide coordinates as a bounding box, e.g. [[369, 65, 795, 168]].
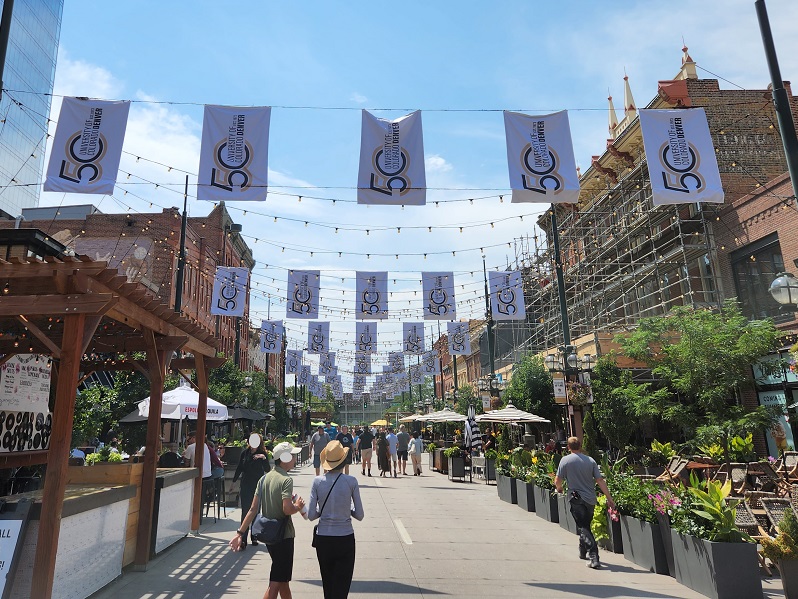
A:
[[308, 441, 364, 599]]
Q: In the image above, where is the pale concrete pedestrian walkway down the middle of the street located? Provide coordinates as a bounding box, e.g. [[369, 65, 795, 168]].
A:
[[90, 454, 783, 599]]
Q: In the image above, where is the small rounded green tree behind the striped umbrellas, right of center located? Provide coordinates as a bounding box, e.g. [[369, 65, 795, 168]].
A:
[[504, 354, 562, 422]]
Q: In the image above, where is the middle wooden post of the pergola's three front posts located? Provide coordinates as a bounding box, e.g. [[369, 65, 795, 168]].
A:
[[133, 329, 167, 570]]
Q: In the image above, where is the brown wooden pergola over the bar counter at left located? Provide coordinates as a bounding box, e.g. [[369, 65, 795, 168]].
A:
[[0, 257, 224, 599]]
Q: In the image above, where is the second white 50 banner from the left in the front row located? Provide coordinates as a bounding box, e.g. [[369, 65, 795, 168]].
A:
[[197, 106, 271, 202]]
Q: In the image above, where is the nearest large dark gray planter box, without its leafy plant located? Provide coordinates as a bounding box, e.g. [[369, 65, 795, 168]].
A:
[[671, 529, 762, 599]]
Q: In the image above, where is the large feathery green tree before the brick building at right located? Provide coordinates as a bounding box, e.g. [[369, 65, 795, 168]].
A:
[[617, 300, 779, 462]]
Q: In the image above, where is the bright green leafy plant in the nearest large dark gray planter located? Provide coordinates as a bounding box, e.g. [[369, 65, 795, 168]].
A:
[[671, 475, 762, 599]]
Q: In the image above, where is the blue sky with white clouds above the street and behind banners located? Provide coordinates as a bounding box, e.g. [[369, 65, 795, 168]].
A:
[[41, 0, 798, 384]]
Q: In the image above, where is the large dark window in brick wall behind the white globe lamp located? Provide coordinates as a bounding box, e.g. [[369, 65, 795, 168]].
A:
[[730, 233, 784, 319]]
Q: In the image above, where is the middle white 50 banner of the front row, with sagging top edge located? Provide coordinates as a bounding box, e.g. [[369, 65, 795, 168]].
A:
[[357, 110, 427, 206]]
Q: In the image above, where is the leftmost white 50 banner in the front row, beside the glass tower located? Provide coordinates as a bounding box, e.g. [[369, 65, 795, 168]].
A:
[[44, 98, 130, 195]]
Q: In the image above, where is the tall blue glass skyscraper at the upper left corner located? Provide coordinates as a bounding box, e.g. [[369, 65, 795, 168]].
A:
[[0, 0, 64, 216]]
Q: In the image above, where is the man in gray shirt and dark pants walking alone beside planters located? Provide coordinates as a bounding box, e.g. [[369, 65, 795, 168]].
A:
[[554, 437, 615, 570]]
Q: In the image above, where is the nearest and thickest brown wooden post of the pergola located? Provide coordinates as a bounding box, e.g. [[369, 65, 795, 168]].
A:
[[31, 314, 86, 599]]
